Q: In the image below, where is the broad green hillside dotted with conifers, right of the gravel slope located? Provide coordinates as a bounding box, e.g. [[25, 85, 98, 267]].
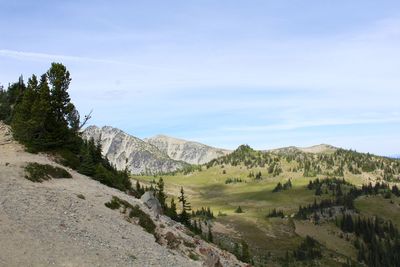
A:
[[135, 145, 400, 266]]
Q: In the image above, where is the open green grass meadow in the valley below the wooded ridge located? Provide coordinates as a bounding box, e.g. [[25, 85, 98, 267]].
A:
[[132, 162, 390, 266]]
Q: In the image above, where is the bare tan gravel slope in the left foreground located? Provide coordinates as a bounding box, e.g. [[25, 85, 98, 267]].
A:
[[0, 125, 244, 266]]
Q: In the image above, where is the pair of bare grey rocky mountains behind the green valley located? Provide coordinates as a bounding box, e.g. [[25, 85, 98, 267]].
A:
[[82, 126, 231, 174]]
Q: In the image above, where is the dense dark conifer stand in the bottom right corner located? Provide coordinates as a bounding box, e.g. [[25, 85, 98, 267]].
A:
[[337, 214, 400, 267]]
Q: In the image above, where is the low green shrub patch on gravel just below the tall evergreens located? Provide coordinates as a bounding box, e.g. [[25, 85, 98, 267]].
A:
[[25, 162, 72, 183]]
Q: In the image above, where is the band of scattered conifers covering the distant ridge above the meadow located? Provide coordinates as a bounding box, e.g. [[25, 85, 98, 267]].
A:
[[206, 142, 400, 181]]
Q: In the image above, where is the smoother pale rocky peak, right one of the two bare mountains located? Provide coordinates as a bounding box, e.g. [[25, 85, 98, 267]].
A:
[[144, 135, 231, 164]]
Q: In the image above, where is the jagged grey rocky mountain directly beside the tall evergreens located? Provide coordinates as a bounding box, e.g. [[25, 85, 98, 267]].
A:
[[82, 126, 186, 174]]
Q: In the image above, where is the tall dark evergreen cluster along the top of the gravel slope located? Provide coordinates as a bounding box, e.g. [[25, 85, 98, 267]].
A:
[[0, 63, 132, 195]]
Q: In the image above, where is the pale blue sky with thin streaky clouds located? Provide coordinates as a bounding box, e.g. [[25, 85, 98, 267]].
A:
[[0, 0, 400, 155]]
